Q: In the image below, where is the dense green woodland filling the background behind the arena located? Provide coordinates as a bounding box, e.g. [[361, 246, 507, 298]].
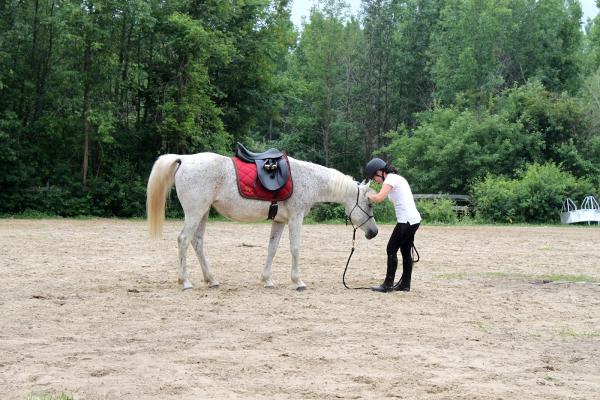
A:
[[0, 0, 600, 222]]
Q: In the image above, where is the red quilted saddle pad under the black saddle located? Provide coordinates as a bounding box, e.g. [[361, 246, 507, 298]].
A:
[[231, 156, 294, 201]]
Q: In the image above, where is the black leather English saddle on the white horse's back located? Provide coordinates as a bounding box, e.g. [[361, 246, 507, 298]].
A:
[[235, 143, 290, 192]]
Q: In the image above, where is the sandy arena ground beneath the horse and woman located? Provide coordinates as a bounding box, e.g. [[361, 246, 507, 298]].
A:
[[0, 220, 600, 400]]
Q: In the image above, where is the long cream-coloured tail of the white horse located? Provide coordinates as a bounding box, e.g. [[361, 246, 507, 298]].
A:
[[146, 154, 181, 238]]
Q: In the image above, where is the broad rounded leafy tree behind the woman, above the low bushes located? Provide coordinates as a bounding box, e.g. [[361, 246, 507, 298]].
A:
[[382, 82, 600, 193]]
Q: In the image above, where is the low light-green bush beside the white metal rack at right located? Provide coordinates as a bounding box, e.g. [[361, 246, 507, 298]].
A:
[[473, 163, 593, 223]]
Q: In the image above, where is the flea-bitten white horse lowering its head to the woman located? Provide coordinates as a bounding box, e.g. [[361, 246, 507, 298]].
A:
[[146, 153, 378, 290]]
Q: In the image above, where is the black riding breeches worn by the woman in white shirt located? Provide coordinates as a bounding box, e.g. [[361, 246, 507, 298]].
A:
[[386, 222, 420, 285]]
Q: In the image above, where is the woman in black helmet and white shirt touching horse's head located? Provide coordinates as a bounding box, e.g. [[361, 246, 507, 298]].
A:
[[365, 158, 421, 293]]
